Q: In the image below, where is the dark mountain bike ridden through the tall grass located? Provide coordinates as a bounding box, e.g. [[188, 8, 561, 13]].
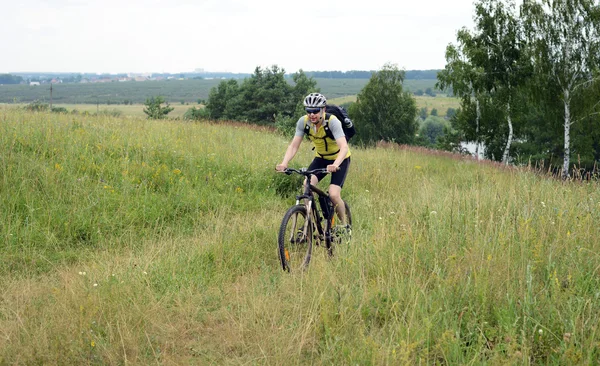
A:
[[277, 168, 352, 272]]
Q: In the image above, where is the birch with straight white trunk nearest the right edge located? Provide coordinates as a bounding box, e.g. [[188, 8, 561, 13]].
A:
[[523, 0, 600, 179]]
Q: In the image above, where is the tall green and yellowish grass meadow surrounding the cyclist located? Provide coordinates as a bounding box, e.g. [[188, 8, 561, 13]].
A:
[[0, 107, 600, 365]]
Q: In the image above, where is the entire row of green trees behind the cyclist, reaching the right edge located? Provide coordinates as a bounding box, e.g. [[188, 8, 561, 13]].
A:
[[170, 0, 600, 178]]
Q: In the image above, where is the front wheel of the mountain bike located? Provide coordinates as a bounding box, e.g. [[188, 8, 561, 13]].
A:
[[277, 205, 313, 272]]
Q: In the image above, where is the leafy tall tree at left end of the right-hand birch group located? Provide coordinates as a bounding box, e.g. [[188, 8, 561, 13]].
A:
[[438, 0, 527, 164]]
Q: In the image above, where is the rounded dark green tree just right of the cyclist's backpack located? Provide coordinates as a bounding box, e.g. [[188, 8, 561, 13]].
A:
[[349, 64, 417, 144]]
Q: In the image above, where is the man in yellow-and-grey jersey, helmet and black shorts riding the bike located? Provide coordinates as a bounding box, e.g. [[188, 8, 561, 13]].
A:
[[275, 93, 350, 226]]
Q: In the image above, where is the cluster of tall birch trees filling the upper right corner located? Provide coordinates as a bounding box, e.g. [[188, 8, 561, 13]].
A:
[[438, 0, 600, 178]]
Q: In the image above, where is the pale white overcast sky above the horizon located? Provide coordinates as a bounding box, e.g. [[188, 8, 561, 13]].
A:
[[0, 0, 473, 73]]
